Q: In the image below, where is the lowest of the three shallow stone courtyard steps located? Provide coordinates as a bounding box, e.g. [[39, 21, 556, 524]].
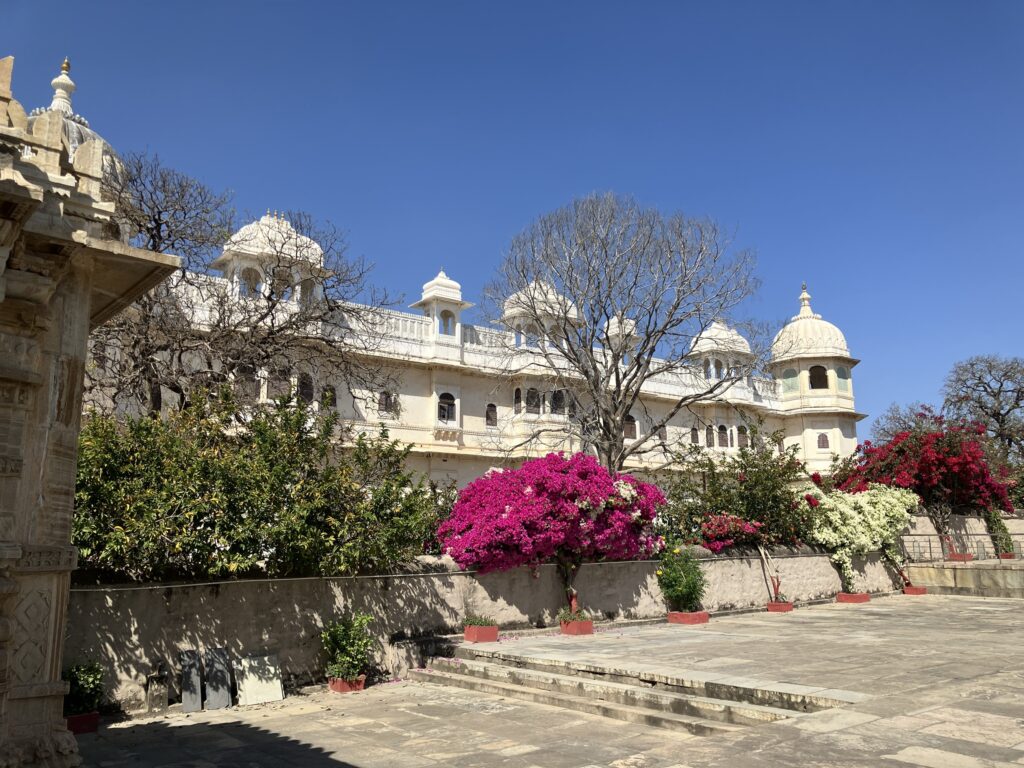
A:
[[409, 670, 743, 736]]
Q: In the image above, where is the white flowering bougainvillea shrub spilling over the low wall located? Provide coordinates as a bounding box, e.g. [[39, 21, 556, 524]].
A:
[[800, 484, 919, 592]]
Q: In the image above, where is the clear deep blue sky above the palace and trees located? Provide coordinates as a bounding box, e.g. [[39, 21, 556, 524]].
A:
[[8, 0, 1024, 437]]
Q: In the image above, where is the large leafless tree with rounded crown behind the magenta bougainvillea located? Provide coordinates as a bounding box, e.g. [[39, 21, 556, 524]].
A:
[[485, 195, 761, 470]]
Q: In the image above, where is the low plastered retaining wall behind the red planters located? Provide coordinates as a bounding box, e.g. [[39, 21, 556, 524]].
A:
[[65, 550, 894, 710]]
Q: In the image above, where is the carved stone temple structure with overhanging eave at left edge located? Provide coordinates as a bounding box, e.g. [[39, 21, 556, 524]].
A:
[[0, 57, 178, 768]]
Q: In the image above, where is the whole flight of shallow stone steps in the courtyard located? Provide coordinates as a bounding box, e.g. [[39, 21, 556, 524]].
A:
[[409, 645, 849, 736]]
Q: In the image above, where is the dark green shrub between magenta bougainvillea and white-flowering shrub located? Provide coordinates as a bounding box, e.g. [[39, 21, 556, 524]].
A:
[[658, 428, 809, 544]]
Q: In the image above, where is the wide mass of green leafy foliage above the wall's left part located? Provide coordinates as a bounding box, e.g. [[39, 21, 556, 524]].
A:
[[73, 393, 437, 580]]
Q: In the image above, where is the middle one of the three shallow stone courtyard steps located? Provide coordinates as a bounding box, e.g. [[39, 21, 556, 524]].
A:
[[431, 658, 800, 725]]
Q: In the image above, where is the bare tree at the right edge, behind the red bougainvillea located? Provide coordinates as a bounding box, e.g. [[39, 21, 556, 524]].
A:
[[942, 354, 1024, 463]]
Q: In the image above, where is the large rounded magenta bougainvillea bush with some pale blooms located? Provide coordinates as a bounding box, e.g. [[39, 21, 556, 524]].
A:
[[437, 454, 665, 598]]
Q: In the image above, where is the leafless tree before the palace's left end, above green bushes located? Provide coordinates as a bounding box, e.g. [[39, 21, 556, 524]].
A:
[[86, 154, 386, 414]]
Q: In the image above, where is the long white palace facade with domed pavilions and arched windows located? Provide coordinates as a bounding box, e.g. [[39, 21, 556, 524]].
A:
[[203, 215, 863, 486]]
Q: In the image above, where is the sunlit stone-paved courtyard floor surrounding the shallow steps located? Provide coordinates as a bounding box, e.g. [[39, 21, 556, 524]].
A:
[[80, 596, 1024, 768]]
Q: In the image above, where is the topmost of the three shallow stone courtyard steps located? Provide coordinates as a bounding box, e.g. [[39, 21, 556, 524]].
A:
[[455, 645, 847, 713]]
